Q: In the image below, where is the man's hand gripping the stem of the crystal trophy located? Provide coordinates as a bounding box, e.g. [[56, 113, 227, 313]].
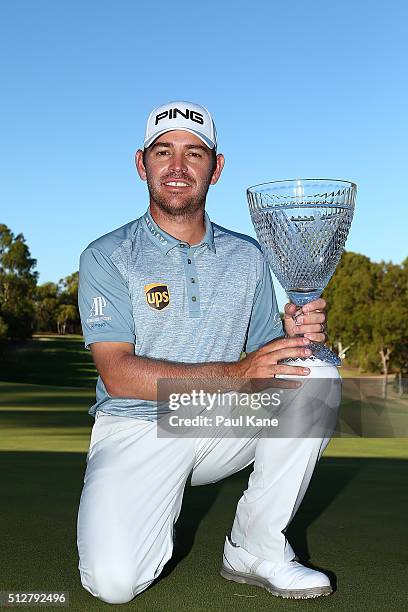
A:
[[284, 298, 326, 342]]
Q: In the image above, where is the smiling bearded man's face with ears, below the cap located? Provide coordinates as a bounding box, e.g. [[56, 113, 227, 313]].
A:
[[136, 130, 224, 216]]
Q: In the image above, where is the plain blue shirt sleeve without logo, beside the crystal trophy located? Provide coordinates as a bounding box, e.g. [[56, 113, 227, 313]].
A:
[[244, 259, 284, 353]]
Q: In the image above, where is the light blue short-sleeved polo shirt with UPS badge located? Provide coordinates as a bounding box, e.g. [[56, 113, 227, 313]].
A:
[[78, 210, 283, 420]]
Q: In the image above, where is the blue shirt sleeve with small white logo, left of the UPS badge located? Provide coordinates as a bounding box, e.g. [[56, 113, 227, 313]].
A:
[[78, 248, 136, 350]]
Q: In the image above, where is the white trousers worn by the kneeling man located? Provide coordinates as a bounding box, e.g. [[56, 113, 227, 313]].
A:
[[77, 366, 341, 603]]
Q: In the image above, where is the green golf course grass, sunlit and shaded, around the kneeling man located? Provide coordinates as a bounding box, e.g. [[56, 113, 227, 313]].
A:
[[0, 336, 408, 612]]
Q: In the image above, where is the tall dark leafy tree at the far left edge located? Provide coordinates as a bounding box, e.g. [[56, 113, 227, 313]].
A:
[[0, 223, 38, 339]]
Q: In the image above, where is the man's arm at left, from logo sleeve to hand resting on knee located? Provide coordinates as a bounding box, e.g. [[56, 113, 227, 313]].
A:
[[78, 247, 308, 400]]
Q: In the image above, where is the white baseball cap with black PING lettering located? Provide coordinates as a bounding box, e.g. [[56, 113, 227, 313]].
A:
[[144, 100, 217, 149]]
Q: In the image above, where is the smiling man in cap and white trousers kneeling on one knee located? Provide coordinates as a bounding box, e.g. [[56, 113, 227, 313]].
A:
[[78, 102, 339, 603]]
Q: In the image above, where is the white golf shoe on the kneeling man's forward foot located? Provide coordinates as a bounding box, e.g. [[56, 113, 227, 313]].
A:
[[221, 537, 333, 599]]
